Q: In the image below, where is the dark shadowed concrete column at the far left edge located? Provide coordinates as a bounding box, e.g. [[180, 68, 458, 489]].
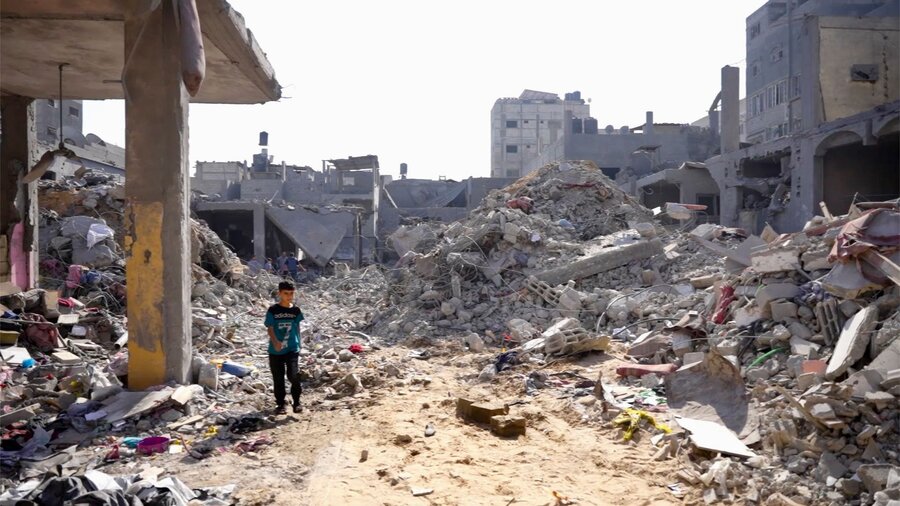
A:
[[0, 95, 40, 288]]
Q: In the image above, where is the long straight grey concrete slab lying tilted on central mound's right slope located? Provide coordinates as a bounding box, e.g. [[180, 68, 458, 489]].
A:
[[536, 239, 663, 286]]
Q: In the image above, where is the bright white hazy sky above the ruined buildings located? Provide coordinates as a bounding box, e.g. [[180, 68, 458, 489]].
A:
[[84, 0, 764, 179]]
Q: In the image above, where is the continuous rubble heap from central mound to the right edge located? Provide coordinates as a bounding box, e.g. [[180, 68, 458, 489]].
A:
[[375, 162, 900, 504]]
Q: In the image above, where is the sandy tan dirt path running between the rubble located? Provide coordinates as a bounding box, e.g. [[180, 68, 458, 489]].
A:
[[130, 348, 683, 506]]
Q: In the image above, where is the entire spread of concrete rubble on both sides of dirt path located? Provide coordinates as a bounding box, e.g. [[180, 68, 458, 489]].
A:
[[0, 161, 900, 504]]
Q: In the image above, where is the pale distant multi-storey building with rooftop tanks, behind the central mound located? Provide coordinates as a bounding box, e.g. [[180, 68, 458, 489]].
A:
[[491, 90, 591, 178]]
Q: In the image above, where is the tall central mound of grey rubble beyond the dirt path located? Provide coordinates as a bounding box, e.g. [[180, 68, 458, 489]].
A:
[[375, 162, 680, 343]]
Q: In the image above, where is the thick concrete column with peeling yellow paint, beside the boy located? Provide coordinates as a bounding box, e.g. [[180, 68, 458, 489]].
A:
[[122, 0, 191, 389]]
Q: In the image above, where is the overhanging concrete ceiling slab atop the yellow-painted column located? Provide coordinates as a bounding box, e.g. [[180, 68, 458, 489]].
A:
[[0, 0, 281, 104]]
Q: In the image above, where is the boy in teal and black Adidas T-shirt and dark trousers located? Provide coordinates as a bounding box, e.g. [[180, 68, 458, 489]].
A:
[[265, 281, 303, 414]]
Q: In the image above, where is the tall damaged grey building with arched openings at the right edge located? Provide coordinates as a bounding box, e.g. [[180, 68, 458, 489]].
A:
[[708, 0, 900, 231]]
